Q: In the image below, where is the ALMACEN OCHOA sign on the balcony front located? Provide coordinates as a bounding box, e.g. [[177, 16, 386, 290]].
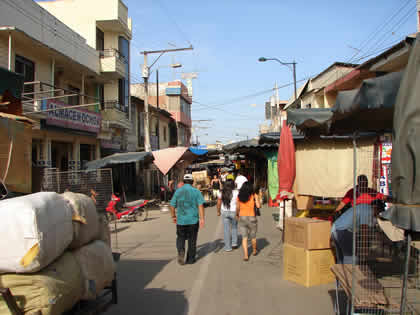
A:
[[46, 100, 101, 133]]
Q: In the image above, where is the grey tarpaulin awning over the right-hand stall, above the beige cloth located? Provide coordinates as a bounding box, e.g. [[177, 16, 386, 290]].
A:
[[287, 71, 403, 135]]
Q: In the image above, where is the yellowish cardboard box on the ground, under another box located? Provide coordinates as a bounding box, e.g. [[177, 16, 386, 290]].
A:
[[283, 244, 335, 287]]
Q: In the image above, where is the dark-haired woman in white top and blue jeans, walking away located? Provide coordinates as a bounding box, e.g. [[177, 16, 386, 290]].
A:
[[217, 180, 239, 252]]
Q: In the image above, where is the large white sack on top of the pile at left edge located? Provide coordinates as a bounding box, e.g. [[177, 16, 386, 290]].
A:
[[0, 192, 73, 273]]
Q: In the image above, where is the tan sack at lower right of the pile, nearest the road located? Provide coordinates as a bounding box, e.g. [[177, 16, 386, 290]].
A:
[[73, 241, 115, 300]]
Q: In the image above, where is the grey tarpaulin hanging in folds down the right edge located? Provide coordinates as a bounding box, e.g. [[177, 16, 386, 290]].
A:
[[383, 34, 420, 232]]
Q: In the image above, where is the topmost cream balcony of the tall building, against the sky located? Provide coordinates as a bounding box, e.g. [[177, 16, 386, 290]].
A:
[[96, 0, 131, 39]]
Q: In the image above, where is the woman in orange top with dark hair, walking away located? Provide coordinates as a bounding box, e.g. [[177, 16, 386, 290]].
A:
[[236, 182, 261, 261]]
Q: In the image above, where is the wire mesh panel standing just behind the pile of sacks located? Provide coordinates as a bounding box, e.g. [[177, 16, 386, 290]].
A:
[[42, 168, 113, 213]]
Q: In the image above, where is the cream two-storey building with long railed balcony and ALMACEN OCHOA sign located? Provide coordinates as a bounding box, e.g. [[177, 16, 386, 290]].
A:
[[0, 0, 102, 178]]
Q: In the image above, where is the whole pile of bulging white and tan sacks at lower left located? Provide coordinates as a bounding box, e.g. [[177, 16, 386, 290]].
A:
[[0, 192, 115, 315]]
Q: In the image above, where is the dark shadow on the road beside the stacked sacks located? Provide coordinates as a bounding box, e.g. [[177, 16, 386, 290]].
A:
[[106, 260, 188, 315]]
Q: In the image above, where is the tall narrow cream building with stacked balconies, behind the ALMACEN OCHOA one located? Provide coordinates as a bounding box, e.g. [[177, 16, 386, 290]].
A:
[[39, 0, 132, 156]]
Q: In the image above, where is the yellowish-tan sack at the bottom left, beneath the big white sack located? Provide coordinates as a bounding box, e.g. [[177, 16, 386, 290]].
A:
[[0, 252, 83, 315]]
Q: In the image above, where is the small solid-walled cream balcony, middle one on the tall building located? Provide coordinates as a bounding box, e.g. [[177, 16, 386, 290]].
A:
[[99, 48, 127, 80]]
